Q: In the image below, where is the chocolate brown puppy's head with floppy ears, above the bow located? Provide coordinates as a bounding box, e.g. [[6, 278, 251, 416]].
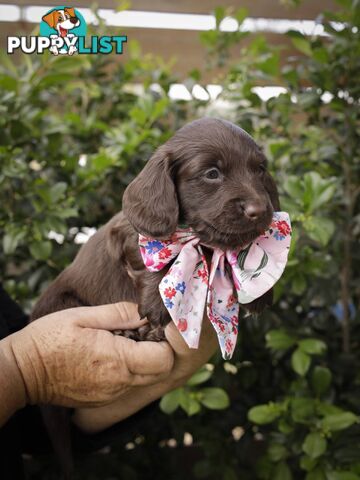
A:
[[123, 118, 280, 249]]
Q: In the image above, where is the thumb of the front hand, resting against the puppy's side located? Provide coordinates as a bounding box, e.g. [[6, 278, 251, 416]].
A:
[[67, 302, 147, 330]]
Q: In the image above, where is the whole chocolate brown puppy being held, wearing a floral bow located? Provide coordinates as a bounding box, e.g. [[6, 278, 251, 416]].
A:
[[32, 118, 280, 472]]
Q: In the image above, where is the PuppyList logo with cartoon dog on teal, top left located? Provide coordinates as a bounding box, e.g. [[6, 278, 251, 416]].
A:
[[7, 7, 127, 55]]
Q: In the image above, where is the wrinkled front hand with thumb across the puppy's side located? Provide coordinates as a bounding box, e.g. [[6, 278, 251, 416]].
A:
[[0, 302, 174, 422]]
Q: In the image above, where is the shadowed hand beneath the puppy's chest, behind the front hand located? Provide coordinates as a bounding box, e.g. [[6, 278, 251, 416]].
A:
[[73, 316, 218, 433]]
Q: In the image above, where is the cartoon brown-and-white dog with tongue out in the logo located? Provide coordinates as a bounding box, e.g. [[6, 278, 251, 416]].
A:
[[42, 7, 80, 55]]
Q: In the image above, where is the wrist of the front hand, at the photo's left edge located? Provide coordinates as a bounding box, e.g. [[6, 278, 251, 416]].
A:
[[0, 334, 27, 425]]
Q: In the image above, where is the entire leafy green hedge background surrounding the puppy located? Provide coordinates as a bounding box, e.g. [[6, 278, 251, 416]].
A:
[[0, 0, 360, 480]]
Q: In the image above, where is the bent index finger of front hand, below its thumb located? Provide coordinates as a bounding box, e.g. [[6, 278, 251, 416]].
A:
[[114, 337, 174, 384]]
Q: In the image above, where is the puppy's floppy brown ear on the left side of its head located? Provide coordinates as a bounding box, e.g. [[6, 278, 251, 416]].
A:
[[123, 146, 179, 238]]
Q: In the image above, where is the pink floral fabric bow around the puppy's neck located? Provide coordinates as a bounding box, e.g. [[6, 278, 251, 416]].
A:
[[139, 212, 291, 359]]
